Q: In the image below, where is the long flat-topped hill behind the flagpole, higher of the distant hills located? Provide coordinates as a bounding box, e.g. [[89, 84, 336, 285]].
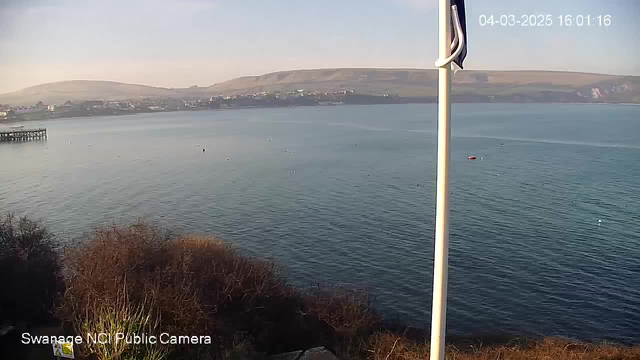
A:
[[207, 69, 640, 102]]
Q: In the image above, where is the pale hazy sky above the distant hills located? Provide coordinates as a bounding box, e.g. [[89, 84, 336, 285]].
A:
[[0, 0, 640, 92]]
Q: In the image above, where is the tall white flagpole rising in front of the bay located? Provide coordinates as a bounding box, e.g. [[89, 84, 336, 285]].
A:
[[430, 0, 452, 360]]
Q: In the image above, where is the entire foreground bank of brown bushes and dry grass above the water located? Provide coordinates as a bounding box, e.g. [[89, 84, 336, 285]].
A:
[[0, 215, 640, 360]]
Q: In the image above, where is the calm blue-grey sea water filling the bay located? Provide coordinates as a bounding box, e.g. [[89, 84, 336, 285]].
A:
[[0, 104, 640, 342]]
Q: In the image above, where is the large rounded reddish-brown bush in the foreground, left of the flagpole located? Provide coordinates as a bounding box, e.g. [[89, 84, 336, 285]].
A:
[[59, 222, 380, 358]]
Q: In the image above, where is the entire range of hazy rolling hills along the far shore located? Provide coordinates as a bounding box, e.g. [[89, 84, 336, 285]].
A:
[[0, 69, 640, 106]]
